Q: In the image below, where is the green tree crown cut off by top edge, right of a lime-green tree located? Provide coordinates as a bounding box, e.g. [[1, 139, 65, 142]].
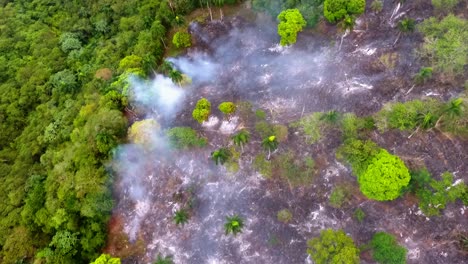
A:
[[323, 0, 366, 23]]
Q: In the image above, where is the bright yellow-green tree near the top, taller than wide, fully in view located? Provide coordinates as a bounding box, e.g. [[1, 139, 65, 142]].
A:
[[278, 9, 306, 46]]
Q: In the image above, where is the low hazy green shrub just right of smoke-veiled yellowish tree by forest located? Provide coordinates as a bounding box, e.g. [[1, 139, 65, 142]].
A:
[[166, 127, 207, 149]]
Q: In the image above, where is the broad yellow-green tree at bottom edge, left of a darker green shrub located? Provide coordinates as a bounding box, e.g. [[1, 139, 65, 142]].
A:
[[307, 229, 359, 264]]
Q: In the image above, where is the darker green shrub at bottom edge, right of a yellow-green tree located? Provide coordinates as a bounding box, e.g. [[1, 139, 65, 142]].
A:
[[370, 232, 407, 264]]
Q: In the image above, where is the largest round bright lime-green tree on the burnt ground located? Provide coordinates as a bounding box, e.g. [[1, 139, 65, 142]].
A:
[[358, 149, 411, 201]]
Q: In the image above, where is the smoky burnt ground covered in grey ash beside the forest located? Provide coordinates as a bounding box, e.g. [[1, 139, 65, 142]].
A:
[[107, 1, 468, 263]]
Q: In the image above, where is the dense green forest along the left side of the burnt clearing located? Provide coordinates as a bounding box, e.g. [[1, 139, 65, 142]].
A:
[[0, 0, 234, 263]]
